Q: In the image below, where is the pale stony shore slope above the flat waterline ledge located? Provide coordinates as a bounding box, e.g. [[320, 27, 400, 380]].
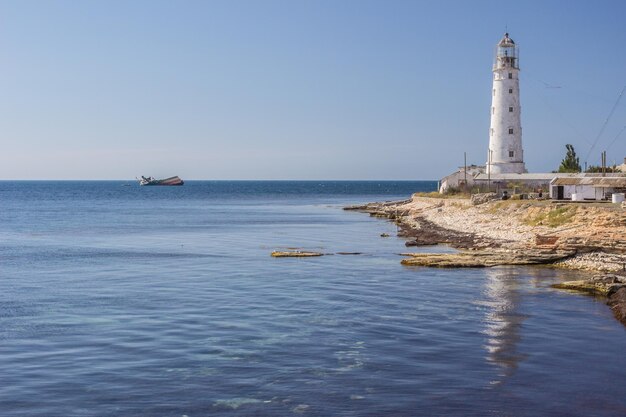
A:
[[344, 194, 626, 273]]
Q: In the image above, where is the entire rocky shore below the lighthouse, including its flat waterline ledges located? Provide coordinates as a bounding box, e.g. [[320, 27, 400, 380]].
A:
[[345, 194, 626, 325]]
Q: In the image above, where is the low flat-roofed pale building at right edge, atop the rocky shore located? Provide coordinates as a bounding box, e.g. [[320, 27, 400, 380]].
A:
[[550, 174, 626, 201]]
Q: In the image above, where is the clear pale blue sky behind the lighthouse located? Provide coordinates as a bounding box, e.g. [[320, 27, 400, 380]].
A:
[[0, 0, 626, 179]]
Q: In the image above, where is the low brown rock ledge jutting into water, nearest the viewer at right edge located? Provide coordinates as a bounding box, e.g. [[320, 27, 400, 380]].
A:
[[552, 274, 626, 325]]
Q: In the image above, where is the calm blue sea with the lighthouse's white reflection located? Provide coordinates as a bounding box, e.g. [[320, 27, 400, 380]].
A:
[[0, 181, 626, 417]]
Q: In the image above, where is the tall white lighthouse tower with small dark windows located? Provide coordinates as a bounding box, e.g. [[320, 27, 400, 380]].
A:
[[487, 33, 527, 174]]
